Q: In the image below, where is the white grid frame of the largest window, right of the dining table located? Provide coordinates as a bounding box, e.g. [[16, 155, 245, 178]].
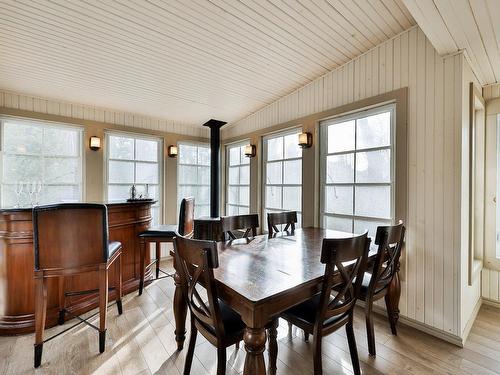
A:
[[319, 103, 397, 233]]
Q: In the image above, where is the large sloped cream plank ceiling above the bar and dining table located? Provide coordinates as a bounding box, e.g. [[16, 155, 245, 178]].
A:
[[0, 0, 415, 124]]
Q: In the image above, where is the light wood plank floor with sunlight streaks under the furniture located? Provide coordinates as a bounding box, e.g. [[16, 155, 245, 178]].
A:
[[0, 262, 500, 375]]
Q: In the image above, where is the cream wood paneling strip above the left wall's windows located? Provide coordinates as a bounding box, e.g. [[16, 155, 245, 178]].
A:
[[0, 91, 208, 137]]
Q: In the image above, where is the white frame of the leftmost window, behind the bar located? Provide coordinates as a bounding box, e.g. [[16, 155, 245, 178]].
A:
[[0, 115, 86, 207]]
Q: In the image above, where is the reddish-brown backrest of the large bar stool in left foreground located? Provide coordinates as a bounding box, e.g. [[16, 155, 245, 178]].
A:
[[33, 203, 109, 270]]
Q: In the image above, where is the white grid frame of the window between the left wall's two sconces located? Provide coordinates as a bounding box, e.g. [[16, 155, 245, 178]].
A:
[[104, 130, 164, 224]]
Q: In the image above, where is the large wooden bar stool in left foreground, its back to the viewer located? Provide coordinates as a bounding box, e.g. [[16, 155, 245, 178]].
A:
[[33, 203, 123, 367]]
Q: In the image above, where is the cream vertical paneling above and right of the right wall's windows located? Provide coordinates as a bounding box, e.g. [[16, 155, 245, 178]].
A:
[[223, 28, 464, 335]]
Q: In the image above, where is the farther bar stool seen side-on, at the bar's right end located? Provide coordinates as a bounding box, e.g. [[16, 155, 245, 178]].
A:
[[139, 197, 194, 295]]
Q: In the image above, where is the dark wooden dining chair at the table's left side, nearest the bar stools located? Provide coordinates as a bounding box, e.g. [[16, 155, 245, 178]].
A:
[[174, 237, 245, 375]]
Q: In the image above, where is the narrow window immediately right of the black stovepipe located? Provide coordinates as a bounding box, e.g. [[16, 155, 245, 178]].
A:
[[226, 144, 250, 215]]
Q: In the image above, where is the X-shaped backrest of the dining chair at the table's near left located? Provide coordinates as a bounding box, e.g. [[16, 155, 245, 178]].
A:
[[174, 236, 224, 337]]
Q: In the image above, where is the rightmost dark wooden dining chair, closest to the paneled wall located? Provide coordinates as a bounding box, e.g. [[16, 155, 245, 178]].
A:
[[359, 221, 405, 355]]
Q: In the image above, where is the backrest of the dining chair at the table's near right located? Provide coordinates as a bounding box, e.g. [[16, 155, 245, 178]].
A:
[[316, 232, 371, 328]]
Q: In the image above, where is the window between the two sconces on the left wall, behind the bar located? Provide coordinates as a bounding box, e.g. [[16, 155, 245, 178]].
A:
[[106, 133, 163, 224]]
